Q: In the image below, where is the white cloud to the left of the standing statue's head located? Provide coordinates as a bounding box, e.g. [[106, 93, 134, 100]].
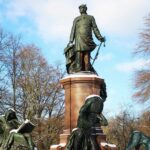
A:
[[2, 0, 77, 40]]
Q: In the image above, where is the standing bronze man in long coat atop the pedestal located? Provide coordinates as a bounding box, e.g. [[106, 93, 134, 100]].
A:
[[65, 5, 105, 72]]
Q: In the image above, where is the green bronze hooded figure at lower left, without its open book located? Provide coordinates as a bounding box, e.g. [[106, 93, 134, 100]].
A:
[[0, 109, 34, 150]]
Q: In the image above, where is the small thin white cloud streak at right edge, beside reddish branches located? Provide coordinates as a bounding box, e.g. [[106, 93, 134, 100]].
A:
[[116, 59, 150, 73]]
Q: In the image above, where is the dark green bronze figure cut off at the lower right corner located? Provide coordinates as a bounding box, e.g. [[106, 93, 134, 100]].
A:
[[126, 131, 150, 150]]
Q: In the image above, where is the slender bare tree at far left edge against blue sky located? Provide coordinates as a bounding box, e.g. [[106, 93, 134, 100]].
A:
[[0, 29, 21, 110]]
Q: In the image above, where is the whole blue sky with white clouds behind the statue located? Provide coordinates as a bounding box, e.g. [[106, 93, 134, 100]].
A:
[[0, 0, 150, 116]]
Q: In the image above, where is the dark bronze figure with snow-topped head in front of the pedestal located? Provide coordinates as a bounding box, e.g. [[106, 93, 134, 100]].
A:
[[66, 95, 108, 150]]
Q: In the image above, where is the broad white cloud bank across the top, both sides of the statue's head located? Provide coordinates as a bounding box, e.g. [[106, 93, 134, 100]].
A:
[[3, 0, 150, 40]]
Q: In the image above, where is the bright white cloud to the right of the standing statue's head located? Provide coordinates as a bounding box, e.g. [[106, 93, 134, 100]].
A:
[[93, 0, 150, 36]]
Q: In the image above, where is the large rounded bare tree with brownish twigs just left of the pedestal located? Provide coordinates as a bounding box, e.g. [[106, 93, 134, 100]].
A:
[[17, 45, 64, 118]]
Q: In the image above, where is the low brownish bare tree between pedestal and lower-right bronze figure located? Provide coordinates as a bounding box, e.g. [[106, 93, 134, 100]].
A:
[[106, 110, 135, 149]]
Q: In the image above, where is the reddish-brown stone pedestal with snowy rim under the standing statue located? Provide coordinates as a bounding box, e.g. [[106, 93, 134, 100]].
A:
[[51, 73, 106, 150]]
